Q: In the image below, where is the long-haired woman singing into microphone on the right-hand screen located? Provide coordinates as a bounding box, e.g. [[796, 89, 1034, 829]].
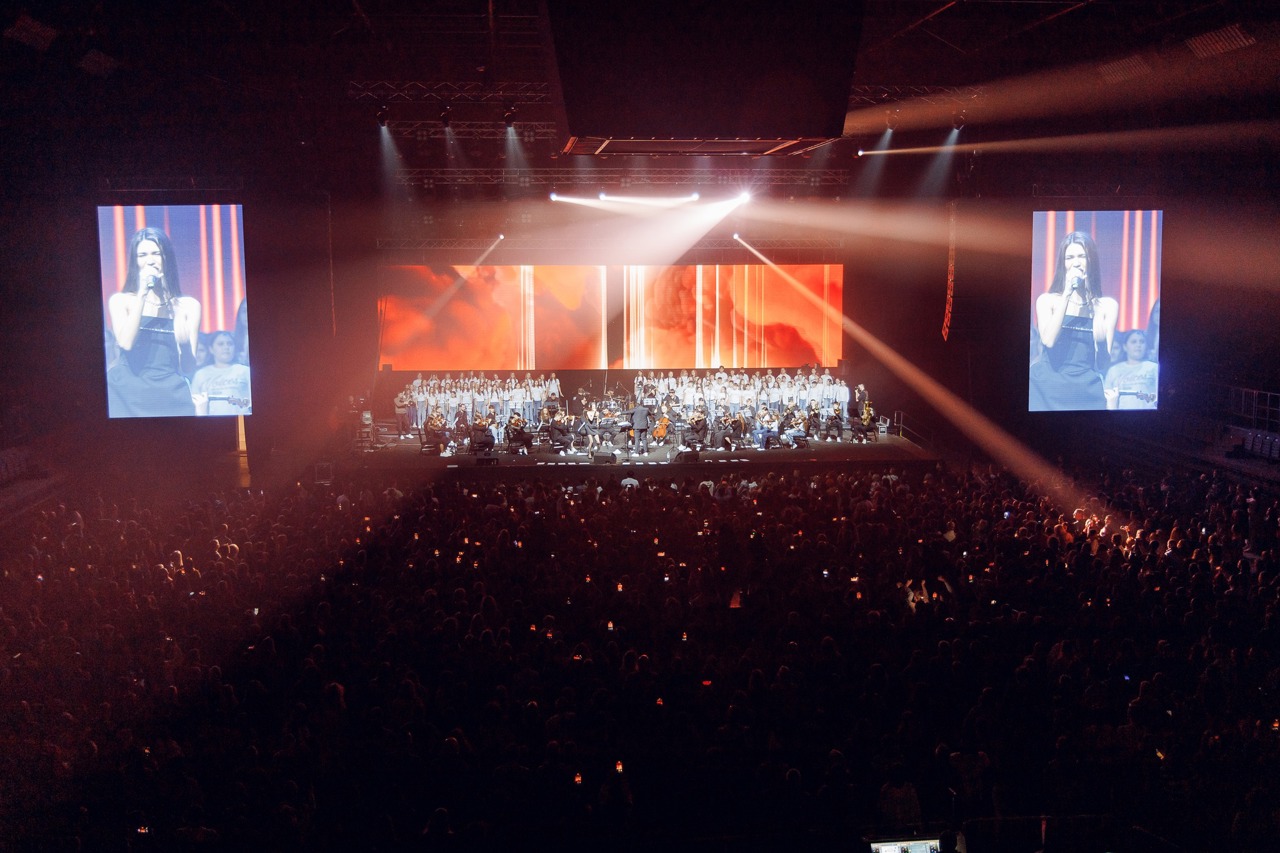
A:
[[1028, 231, 1119, 411]]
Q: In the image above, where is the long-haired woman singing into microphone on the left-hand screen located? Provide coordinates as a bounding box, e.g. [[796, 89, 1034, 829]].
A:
[[106, 228, 200, 418]]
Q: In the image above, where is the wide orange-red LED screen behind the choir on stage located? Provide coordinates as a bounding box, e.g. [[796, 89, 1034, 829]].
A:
[[379, 264, 844, 370]]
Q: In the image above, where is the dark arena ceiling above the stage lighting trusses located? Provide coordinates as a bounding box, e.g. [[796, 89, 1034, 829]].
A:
[[0, 0, 1277, 162]]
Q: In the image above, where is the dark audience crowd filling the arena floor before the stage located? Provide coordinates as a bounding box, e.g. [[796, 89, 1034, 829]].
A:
[[0, 462, 1280, 853]]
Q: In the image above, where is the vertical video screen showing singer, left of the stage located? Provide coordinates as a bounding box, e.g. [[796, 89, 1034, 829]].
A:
[[97, 205, 252, 418]]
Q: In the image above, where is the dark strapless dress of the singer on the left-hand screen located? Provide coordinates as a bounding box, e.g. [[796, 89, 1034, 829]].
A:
[[106, 316, 196, 418]]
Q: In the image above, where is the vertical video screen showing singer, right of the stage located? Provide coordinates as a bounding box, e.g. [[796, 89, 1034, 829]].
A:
[[1027, 210, 1164, 411]]
